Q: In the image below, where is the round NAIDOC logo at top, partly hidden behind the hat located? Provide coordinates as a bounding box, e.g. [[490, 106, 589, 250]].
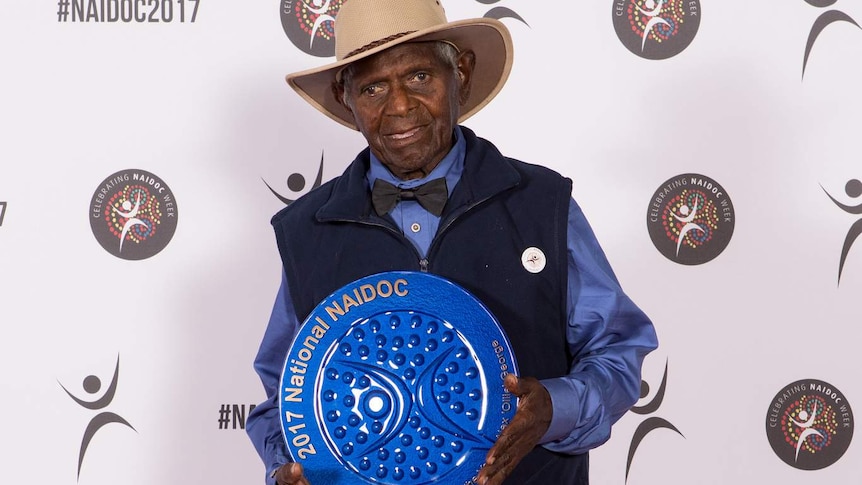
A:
[[281, 0, 347, 57]]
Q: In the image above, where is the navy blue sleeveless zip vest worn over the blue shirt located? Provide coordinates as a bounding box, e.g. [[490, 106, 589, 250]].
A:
[[272, 127, 587, 485]]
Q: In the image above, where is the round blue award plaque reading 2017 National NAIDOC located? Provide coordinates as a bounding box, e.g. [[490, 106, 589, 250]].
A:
[[279, 271, 517, 485]]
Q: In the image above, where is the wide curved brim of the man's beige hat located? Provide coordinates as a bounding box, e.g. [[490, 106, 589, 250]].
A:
[[286, 18, 514, 130]]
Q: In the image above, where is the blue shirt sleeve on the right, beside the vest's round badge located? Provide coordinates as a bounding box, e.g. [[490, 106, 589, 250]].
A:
[[541, 200, 658, 454]]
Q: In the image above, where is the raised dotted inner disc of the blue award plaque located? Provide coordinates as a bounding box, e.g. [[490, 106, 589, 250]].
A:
[[316, 311, 490, 483]]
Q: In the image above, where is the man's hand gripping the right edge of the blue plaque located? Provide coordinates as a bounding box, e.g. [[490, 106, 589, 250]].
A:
[[479, 374, 554, 485]]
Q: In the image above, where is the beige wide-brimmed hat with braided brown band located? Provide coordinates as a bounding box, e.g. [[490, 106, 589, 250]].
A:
[[287, 0, 513, 130]]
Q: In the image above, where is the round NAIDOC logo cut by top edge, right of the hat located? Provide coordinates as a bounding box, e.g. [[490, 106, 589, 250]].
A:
[[613, 0, 701, 60]]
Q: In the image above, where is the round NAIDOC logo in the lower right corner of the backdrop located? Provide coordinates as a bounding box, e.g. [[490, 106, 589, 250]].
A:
[[766, 379, 853, 470]]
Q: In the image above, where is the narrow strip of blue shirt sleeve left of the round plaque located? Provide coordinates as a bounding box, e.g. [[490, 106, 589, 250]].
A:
[[246, 274, 300, 485]]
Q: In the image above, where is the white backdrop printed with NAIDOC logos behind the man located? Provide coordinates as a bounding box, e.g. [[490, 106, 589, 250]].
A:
[[0, 0, 862, 485]]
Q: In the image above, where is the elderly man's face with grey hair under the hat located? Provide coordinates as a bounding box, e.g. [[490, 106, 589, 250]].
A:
[[335, 42, 473, 180]]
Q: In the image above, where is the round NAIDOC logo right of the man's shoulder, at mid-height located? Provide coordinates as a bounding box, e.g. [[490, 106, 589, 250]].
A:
[[647, 173, 736, 265]]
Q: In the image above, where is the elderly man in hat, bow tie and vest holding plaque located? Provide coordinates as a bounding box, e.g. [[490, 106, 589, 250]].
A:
[[248, 0, 657, 485]]
